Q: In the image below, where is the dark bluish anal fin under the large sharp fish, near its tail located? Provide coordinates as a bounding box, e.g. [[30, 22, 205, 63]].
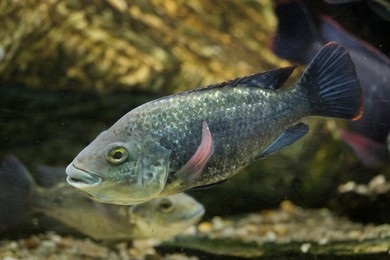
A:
[[257, 123, 309, 159]]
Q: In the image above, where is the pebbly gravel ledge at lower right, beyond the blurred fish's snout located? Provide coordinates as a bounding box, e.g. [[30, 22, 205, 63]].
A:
[[158, 201, 390, 259]]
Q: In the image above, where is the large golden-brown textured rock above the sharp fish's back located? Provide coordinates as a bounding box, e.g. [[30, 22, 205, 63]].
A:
[[0, 0, 277, 91]]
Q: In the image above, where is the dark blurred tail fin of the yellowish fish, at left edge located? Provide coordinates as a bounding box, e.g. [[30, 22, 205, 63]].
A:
[[0, 155, 35, 232]]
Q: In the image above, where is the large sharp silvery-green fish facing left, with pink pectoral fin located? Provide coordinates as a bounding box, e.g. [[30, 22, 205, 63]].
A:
[[66, 43, 362, 204]]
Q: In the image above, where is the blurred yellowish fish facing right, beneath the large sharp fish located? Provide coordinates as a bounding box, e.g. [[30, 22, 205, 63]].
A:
[[0, 156, 205, 240]]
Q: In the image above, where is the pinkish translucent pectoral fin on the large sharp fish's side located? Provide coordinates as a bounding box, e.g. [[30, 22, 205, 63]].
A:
[[175, 122, 214, 183]]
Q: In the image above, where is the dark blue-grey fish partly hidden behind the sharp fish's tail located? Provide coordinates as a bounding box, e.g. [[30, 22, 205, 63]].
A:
[[272, 0, 390, 167]]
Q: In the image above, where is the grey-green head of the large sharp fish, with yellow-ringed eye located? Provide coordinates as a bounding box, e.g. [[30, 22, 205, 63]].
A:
[[66, 129, 170, 205]]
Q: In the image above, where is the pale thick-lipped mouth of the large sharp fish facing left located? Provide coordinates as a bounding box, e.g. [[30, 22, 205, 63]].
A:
[[65, 163, 103, 189]]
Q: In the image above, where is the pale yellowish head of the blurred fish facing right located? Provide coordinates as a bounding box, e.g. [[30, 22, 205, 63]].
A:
[[129, 193, 205, 239]]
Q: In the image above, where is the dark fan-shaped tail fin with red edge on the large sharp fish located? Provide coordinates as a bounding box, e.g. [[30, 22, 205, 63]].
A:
[[298, 42, 363, 120]]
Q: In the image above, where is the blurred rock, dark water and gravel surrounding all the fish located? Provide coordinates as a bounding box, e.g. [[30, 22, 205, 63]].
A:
[[0, 0, 390, 259]]
